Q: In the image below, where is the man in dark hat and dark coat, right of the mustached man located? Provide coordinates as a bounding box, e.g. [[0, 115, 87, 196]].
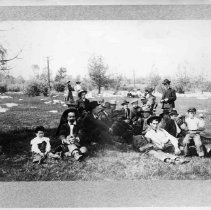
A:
[[79, 101, 111, 144]]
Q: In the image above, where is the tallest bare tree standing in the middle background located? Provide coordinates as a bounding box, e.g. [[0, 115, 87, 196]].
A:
[[88, 56, 110, 94]]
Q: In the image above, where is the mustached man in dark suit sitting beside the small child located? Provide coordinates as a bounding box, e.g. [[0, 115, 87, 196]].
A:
[[59, 109, 87, 161]]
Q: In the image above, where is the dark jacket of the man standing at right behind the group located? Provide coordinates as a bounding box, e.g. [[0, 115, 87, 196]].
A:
[[161, 88, 177, 109]]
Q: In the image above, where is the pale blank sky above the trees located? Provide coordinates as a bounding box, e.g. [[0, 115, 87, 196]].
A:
[[0, 20, 211, 80]]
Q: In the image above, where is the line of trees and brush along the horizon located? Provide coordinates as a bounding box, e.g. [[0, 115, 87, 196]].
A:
[[0, 56, 211, 95]]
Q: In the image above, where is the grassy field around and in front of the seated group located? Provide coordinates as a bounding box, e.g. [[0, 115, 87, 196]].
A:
[[0, 94, 211, 181]]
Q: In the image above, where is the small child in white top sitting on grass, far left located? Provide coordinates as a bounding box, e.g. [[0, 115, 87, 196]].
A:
[[30, 126, 60, 164]]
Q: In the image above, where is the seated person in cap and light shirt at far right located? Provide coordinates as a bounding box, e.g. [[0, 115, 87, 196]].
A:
[[183, 107, 205, 157]]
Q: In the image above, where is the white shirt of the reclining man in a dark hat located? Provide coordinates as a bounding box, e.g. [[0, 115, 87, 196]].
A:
[[145, 128, 177, 149]]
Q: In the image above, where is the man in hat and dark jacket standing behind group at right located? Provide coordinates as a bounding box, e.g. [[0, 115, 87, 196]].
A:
[[160, 79, 177, 112]]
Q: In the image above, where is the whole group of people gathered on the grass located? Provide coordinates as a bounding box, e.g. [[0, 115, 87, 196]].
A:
[[31, 79, 210, 163]]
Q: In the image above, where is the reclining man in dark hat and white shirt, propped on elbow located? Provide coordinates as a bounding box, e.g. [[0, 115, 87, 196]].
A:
[[139, 116, 189, 163]]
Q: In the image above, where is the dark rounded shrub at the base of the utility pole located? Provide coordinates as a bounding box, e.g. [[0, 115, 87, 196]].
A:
[[24, 81, 49, 97]]
